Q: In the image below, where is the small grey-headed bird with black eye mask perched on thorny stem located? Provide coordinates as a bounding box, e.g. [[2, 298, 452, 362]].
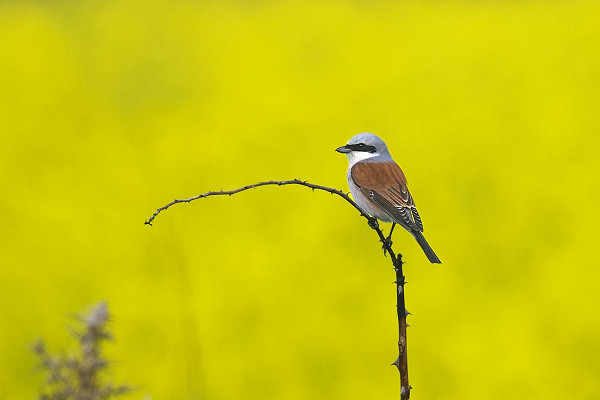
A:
[[335, 132, 442, 264]]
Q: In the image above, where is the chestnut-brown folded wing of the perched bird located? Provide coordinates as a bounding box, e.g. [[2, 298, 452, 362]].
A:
[[351, 162, 423, 232]]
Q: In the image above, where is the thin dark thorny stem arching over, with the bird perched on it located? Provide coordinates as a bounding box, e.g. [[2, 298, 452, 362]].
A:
[[144, 179, 411, 400]]
